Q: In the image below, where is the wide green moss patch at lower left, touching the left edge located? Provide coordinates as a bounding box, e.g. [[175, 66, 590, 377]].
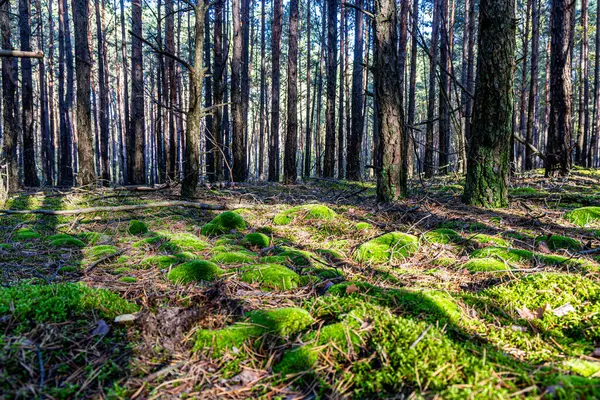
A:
[[0, 283, 138, 324]]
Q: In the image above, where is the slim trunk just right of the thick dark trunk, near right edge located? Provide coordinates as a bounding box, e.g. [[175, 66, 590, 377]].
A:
[[576, 0, 599, 166]]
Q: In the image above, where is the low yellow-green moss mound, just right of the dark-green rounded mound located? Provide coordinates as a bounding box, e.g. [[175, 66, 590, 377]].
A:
[[241, 264, 301, 290]]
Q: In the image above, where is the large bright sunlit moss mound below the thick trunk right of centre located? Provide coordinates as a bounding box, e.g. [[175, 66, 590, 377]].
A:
[[354, 232, 419, 264]]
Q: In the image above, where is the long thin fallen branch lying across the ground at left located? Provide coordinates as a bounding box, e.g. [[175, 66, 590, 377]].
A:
[[0, 201, 225, 215]]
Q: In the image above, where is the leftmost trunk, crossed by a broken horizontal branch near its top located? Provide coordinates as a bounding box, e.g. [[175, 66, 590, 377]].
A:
[[0, 1, 21, 192]]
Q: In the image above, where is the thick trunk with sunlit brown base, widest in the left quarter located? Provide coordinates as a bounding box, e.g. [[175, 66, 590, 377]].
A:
[[73, 0, 96, 185]]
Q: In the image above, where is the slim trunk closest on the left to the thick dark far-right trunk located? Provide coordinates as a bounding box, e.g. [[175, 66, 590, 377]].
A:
[[525, 0, 540, 171]]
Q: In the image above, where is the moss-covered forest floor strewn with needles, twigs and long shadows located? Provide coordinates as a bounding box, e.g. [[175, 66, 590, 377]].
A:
[[0, 170, 600, 399]]
